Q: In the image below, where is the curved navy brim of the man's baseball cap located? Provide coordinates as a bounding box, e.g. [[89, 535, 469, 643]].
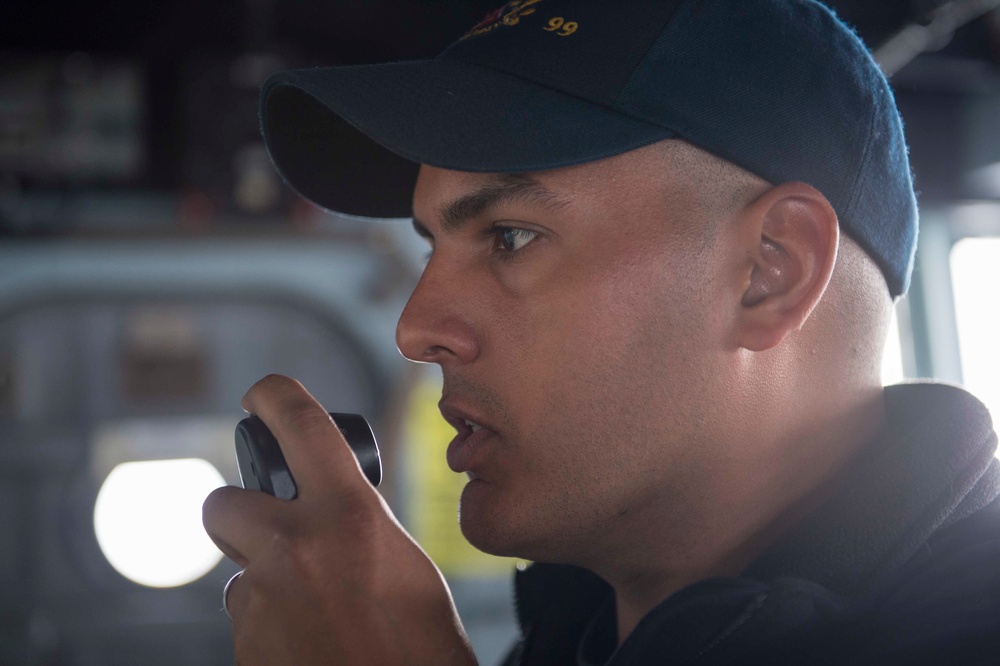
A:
[[261, 59, 673, 217]]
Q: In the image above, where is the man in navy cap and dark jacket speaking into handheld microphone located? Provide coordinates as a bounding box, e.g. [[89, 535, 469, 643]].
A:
[[199, 0, 1000, 665]]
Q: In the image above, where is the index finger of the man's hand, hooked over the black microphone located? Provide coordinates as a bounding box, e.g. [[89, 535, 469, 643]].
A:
[[241, 375, 368, 496]]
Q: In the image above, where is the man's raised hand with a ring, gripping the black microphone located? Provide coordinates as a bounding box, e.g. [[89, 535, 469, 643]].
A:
[[203, 375, 476, 666]]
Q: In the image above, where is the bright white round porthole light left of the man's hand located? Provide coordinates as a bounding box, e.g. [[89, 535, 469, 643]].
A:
[[94, 458, 225, 587]]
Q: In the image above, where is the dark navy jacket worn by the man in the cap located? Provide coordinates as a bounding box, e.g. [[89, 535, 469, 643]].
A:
[[504, 384, 1000, 666]]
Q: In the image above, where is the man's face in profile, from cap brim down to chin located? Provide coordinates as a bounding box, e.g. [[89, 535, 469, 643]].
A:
[[397, 145, 738, 566]]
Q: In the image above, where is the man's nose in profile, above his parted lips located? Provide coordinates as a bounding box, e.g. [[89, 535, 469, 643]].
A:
[[396, 257, 479, 365]]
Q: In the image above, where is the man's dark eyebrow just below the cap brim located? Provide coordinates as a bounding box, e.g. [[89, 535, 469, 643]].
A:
[[413, 173, 570, 238]]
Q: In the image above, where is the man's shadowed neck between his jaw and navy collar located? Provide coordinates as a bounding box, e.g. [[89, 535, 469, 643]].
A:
[[597, 386, 885, 644]]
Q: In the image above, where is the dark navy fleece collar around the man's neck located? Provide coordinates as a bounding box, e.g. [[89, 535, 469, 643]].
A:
[[516, 384, 1000, 666]]
